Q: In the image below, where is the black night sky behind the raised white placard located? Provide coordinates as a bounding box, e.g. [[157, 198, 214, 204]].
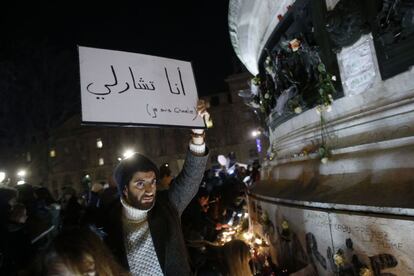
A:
[[0, 0, 237, 149]]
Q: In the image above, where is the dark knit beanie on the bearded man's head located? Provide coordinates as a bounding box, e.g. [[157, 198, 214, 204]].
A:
[[114, 153, 159, 195]]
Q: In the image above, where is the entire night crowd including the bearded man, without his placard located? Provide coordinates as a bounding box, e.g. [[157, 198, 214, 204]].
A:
[[0, 101, 266, 276]]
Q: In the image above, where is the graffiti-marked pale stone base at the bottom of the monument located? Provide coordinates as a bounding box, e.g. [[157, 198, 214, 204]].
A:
[[250, 200, 414, 276]]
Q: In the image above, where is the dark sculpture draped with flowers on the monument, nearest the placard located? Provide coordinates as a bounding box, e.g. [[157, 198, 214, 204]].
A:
[[245, 35, 336, 121]]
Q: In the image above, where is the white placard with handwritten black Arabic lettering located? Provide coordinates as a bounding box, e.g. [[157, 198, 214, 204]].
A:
[[79, 46, 205, 128]]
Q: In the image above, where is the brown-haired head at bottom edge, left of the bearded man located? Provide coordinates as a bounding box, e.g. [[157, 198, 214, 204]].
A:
[[33, 228, 129, 276]]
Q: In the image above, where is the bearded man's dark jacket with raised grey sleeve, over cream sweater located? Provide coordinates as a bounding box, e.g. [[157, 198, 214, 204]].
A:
[[104, 152, 208, 276]]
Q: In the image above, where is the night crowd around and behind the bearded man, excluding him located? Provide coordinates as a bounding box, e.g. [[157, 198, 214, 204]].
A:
[[0, 156, 264, 275]]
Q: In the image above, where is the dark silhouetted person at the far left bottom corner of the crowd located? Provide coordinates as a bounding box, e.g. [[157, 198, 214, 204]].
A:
[[0, 203, 33, 275]]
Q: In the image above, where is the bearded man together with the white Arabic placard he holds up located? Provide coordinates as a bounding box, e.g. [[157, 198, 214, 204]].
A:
[[79, 46, 210, 276]]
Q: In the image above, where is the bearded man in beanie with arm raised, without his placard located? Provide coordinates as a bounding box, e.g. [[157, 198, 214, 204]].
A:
[[100, 101, 209, 275]]
